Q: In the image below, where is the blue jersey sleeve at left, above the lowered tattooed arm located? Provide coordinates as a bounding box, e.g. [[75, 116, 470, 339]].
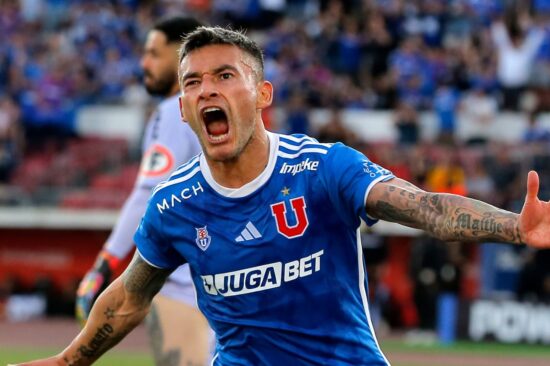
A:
[[134, 196, 186, 269]]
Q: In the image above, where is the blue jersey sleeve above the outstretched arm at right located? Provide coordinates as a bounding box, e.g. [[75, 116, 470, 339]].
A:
[[321, 143, 394, 226]]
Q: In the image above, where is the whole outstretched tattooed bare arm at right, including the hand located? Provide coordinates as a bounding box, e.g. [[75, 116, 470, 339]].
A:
[[366, 172, 550, 248]]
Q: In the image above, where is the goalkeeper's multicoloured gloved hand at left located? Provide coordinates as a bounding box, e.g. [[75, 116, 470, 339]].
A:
[[75, 251, 118, 327]]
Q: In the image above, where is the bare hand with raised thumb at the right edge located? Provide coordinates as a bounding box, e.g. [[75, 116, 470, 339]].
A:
[[519, 171, 550, 248]]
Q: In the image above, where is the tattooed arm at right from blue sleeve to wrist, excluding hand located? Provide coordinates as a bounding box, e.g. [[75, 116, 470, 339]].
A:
[[368, 185, 521, 243]]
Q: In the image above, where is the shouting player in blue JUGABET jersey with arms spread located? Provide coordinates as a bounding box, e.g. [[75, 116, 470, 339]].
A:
[[15, 27, 550, 366]]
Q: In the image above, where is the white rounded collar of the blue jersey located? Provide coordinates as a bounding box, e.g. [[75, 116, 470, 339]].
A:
[[200, 131, 279, 198]]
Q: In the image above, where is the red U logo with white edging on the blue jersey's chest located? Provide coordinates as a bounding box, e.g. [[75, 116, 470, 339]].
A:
[[271, 196, 309, 239]]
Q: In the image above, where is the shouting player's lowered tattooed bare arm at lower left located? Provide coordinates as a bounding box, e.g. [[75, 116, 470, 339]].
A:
[[16, 252, 172, 366]]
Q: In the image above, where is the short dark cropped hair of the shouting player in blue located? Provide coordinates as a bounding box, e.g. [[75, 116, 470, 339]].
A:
[[179, 26, 264, 79]]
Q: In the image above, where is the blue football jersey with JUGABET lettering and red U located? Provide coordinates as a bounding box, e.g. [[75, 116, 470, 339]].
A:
[[135, 133, 393, 366]]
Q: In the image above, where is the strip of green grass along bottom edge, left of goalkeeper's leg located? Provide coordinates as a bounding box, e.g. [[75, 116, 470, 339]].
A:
[[0, 347, 153, 366]]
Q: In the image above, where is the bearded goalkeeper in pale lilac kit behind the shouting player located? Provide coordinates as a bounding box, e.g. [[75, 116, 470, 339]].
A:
[[76, 17, 211, 366]]
